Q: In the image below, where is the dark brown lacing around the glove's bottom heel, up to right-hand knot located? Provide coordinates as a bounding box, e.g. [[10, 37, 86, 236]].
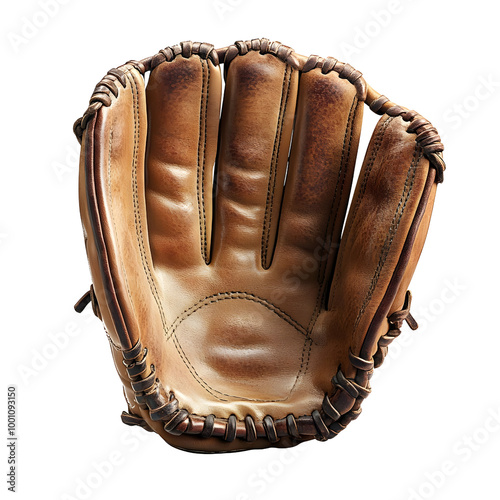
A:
[[103, 292, 417, 443]]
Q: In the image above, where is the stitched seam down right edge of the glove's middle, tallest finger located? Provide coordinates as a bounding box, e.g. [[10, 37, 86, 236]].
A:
[[261, 65, 293, 269]]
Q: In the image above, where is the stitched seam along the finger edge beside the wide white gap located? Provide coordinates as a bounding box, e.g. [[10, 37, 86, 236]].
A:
[[308, 97, 359, 332]]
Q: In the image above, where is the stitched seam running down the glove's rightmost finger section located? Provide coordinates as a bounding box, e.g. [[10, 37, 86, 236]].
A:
[[353, 144, 422, 336]]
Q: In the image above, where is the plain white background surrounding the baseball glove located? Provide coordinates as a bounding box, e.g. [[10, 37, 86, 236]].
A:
[[0, 0, 500, 500]]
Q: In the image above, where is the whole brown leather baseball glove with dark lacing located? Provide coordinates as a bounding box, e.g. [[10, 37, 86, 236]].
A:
[[74, 38, 445, 452]]
